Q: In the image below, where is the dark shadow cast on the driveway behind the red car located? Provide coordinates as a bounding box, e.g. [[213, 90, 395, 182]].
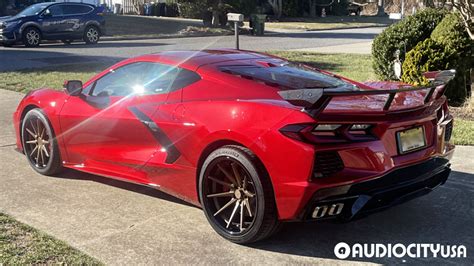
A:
[[251, 171, 474, 265]]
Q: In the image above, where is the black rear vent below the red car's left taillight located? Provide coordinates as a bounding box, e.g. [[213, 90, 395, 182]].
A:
[[313, 151, 344, 178]]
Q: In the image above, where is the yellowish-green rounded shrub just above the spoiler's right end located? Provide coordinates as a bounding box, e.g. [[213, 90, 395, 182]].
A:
[[402, 39, 466, 105]]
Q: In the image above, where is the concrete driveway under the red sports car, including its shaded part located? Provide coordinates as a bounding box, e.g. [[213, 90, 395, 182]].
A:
[[0, 90, 474, 265]]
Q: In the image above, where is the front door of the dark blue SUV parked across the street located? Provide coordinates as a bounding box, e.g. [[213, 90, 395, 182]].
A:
[[38, 4, 65, 39]]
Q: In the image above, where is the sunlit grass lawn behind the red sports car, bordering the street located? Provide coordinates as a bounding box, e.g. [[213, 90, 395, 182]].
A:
[[0, 51, 474, 145]]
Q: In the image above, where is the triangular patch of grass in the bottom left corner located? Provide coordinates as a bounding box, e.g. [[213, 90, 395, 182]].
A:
[[0, 213, 102, 265]]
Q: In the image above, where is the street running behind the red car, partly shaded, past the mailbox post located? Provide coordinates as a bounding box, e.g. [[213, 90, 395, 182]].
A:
[[0, 28, 383, 71]]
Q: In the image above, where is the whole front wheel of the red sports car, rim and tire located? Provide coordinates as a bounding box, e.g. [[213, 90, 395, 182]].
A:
[[21, 108, 63, 175]]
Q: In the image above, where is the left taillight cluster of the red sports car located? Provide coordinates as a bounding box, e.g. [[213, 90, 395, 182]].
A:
[[280, 123, 377, 143]]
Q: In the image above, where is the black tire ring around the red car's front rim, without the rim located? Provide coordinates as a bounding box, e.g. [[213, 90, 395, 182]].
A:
[[20, 108, 61, 175]]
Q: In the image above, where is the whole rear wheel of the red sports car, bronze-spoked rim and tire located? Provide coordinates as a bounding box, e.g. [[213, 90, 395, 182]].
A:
[[199, 145, 280, 244]]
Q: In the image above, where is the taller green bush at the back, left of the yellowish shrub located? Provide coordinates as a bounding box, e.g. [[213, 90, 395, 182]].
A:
[[372, 8, 446, 80]]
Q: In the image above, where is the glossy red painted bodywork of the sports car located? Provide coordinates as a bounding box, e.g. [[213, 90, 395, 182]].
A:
[[14, 50, 454, 220]]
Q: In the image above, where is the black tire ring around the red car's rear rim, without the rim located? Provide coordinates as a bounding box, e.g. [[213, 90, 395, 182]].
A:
[[199, 147, 266, 244]]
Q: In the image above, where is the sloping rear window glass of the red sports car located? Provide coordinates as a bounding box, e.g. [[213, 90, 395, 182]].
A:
[[222, 63, 349, 89]]
